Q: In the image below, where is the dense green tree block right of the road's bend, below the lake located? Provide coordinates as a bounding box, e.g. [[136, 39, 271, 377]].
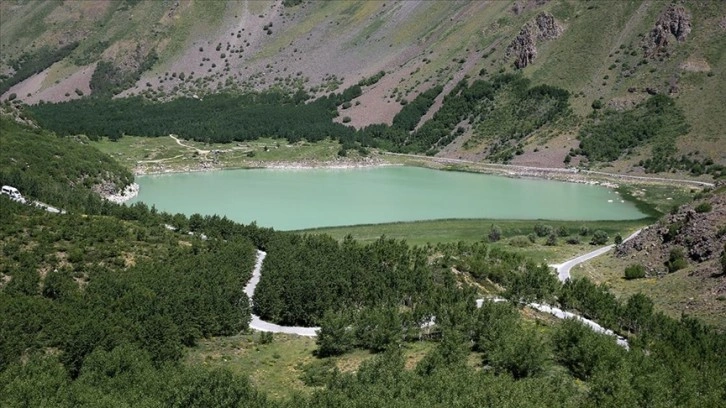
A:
[[254, 234, 446, 326]]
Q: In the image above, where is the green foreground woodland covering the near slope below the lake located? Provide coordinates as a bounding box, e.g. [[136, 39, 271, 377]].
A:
[[0, 116, 726, 407]]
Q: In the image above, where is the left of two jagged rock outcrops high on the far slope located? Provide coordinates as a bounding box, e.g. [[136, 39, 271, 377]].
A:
[[507, 12, 563, 69]]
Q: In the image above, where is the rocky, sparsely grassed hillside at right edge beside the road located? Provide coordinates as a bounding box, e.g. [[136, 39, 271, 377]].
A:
[[573, 185, 726, 329]]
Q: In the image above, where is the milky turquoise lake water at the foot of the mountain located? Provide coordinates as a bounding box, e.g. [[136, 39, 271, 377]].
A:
[[130, 166, 645, 230]]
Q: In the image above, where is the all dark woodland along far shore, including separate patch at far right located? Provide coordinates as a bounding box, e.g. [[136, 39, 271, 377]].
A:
[[19, 67, 725, 174]]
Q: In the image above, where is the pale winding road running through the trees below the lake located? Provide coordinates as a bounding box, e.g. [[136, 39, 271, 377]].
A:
[[245, 230, 641, 349]]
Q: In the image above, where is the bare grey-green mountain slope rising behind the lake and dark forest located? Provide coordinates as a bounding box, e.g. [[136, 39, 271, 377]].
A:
[[0, 0, 726, 176]]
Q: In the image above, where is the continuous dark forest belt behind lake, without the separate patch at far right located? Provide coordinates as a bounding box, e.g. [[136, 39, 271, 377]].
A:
[[27, 74, 569, 157]]
